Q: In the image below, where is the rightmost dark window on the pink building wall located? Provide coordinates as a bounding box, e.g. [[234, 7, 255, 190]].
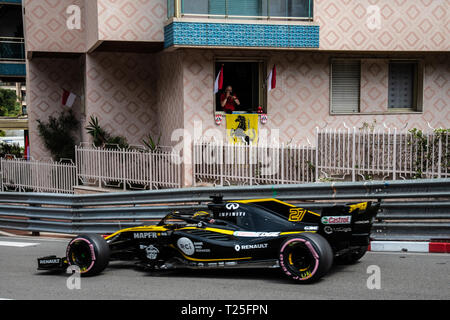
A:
[[389, 61, 418, 110]]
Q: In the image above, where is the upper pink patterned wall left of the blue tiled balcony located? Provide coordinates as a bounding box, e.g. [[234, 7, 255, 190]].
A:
[[24, 0, 167, 52]]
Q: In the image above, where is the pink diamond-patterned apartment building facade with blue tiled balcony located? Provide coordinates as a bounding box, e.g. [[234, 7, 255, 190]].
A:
[[23, 0, 450, 185]]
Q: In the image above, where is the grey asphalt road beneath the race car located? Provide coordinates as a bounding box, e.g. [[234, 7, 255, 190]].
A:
[[0, 237, 450, 300]]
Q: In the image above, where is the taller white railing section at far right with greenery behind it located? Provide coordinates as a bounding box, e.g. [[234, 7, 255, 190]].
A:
[[315, 128, 450, 181]]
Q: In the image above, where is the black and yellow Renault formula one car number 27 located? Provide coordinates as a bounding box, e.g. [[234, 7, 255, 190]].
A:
[[38, 196, 380, 283]]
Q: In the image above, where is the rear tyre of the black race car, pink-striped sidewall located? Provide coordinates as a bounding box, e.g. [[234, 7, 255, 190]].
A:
[[279, 233, 333, 283]]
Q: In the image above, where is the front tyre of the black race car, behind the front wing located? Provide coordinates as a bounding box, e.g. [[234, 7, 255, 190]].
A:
[[66, 234, 110, 277]]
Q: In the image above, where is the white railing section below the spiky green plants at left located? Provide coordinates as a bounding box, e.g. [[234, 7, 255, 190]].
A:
[[75, 147, 181, 190]]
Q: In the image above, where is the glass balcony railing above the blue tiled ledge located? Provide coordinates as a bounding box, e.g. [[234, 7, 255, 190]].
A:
[[167, 0, 314, 20]]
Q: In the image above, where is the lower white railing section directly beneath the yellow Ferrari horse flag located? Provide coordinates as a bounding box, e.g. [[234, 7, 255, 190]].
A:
[[193, 142, 315, 185]]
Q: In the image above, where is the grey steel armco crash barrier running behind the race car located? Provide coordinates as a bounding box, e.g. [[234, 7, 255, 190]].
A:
[[0, 179, 450, 240]]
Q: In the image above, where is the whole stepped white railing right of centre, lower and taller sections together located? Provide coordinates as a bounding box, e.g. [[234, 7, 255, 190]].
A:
[[193, 128, 450, 185]]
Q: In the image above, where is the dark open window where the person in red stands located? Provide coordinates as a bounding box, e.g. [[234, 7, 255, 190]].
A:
[[215, 59, 266, 113]]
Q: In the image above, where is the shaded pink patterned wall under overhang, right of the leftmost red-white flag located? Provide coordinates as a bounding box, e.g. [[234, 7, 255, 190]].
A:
[[83, 53, 159, 145]]
